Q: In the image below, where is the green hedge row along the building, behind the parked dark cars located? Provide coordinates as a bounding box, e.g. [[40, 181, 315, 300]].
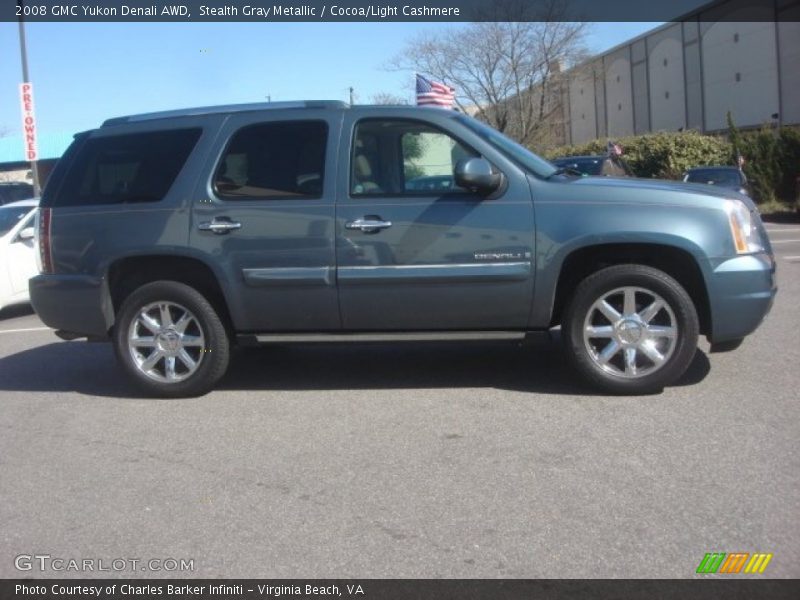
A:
[[545, 127, 800, 202]]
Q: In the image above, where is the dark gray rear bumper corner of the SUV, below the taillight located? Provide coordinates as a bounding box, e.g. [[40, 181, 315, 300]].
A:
[[29, 275, 114, 337]]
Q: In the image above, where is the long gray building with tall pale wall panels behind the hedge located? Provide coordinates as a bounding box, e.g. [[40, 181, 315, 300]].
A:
[[562, 0, 800, 143]]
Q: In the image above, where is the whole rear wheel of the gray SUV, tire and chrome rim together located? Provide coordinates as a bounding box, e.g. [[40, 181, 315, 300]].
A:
[[113, 281, 230, 397]]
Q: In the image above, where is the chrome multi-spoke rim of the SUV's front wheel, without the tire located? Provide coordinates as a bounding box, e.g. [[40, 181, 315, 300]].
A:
[[583, 287, 678, 379]]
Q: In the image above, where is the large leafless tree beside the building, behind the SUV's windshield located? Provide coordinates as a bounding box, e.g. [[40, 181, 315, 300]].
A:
[[389, 0, 586, 145]]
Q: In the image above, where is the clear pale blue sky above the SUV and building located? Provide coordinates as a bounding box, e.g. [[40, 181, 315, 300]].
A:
[[0, 23, 659, 134]]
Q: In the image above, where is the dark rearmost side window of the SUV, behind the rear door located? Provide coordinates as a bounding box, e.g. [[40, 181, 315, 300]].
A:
[[53, 129, 201, 206]]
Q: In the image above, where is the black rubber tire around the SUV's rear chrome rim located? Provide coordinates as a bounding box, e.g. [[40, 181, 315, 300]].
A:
[[113, 281, 230, 398]]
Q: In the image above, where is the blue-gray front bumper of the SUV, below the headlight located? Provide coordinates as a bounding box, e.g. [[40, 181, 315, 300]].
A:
[[708, 253, 778, 344]]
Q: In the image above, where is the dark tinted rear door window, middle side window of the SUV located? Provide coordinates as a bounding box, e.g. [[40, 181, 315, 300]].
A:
[[214, 121, 328, 199]]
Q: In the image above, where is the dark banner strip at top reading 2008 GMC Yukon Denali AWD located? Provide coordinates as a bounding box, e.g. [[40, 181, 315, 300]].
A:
[[0, 0, 800, 23]]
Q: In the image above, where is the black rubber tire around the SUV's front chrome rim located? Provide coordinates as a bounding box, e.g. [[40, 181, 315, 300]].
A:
[[561, 264, 699, 395]]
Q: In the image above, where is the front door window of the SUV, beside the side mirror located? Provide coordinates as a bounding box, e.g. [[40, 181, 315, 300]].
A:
[[350, 120, 477, 196]]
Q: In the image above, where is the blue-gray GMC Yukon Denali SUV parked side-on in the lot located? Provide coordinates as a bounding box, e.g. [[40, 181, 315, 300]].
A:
[[30, 102, 776, 396]]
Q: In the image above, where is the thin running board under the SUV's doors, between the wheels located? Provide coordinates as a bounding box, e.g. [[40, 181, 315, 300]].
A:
[[244, 331, 529, 344]]
